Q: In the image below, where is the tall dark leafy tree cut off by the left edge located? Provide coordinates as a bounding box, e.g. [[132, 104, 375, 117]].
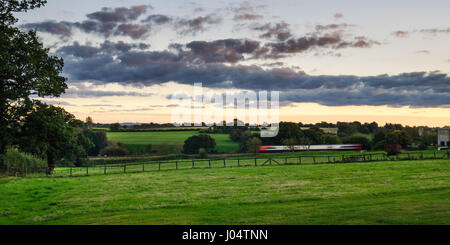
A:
[[0, 0, 67, 164]]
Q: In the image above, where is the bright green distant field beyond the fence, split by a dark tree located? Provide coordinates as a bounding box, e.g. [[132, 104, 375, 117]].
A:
[[107, 131, 238, 154]]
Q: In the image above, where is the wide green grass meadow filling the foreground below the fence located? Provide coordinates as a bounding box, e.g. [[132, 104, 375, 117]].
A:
[[0, 160, 450, 224]]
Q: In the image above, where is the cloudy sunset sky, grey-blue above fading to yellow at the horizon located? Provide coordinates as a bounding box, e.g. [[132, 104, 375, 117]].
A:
[[17, 0, 450, 126]]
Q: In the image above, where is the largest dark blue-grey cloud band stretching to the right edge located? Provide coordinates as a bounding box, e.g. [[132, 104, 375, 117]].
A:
[[57, 40, 450, 107]]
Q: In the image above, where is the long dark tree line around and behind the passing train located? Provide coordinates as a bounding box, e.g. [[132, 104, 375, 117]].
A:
[[225, 121, 437, 152]]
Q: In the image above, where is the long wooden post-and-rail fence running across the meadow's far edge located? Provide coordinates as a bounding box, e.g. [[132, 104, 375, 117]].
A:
[[7, 152, 449, 177]]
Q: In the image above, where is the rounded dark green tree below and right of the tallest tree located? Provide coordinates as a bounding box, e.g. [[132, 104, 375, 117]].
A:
[[19, 102, 92, 172]]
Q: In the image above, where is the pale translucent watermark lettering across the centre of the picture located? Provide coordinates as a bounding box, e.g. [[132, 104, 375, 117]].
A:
[[171, 83, 279, 137]]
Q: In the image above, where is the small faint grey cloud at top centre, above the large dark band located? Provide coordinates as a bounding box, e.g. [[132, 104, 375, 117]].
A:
[[175, 15, 222, 35]]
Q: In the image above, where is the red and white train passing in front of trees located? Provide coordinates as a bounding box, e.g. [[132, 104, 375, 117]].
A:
[[259, 144, 362, 152]]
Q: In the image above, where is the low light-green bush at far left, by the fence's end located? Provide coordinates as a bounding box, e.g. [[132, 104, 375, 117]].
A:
[[3, 148, 47, 174]]
